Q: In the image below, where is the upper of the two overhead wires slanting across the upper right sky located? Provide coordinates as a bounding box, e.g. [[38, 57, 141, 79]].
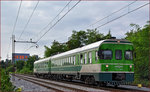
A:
[[86, 0, 137, 28]]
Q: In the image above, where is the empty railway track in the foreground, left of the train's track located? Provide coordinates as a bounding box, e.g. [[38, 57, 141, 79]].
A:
[[13, 74, 106, 92]]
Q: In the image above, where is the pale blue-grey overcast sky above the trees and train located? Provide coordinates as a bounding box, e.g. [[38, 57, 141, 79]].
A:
[[1, 1, 149, 59]]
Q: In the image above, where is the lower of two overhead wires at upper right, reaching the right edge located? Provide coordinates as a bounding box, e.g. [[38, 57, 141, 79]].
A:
[[96, 3, 150, 29]]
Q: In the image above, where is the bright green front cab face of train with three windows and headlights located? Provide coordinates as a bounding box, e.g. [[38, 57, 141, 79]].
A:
[[96, 42, 134, 85]]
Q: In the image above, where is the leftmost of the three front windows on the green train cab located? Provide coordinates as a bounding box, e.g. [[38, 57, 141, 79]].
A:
[[99, 50, 112, 59]]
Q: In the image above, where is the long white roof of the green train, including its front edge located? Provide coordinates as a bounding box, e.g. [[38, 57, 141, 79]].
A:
[[35, 39, 131, 63]]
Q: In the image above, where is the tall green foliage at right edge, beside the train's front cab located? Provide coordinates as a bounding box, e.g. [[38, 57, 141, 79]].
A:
[[126, 24, 150, 85]]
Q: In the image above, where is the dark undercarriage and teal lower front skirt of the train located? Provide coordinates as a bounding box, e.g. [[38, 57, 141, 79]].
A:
[[34, 73, 134, 87]]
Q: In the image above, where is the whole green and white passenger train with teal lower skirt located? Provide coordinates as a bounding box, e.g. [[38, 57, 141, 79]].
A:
[[34, 39, 134, 86]]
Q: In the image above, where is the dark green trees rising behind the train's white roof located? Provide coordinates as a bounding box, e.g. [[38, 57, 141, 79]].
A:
[[44, 29, 111, 57]]
